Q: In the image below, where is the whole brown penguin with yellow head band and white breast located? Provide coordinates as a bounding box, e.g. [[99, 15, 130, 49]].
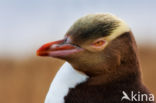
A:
[[37, 13, 155, 103]]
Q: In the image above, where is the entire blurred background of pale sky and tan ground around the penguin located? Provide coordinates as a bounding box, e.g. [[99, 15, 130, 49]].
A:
[[0, 0, 156, 103]]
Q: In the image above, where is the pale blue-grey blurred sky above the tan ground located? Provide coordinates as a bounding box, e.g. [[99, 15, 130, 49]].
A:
[[0, 0, 156, 56]]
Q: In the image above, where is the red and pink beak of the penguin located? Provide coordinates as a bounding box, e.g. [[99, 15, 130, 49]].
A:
[[36, 39, 83, 58]]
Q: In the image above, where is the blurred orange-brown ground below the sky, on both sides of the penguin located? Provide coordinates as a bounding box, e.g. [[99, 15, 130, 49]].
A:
[[0, 47, 156, 103]]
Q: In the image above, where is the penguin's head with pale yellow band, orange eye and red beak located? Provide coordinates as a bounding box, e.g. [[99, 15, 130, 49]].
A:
[[37, 13, 136, 76]]
